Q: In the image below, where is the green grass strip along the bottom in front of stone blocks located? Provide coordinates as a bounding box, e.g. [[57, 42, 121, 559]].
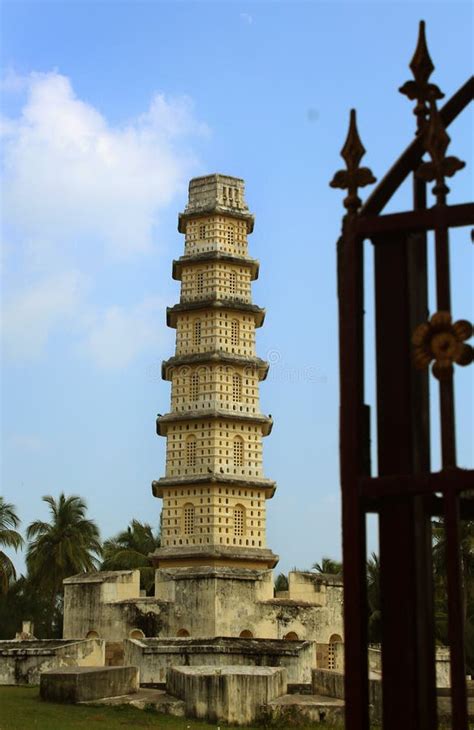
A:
[[0, 687, 335, 730]]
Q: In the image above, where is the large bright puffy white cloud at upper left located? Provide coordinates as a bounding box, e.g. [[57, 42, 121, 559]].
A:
[[3, 73, 205, 255]]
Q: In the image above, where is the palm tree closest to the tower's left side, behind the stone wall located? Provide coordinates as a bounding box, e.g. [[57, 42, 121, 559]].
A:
[[100, 520, 161, 593]]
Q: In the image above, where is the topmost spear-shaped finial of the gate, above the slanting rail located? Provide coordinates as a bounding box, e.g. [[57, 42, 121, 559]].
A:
[[399, 20, 444, 132]]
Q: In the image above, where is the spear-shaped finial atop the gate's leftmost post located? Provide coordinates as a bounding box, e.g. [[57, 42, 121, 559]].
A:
[[329, 109, 376, 213]]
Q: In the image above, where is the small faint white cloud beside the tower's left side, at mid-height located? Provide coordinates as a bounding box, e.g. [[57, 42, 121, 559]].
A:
[[81, 298, 168, 369]]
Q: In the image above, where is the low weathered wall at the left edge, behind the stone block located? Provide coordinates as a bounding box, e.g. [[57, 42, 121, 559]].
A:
[[0, 639, 105, 685]]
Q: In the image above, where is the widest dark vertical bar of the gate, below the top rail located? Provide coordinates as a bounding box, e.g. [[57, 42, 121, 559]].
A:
[[373, 233, 433, 730]]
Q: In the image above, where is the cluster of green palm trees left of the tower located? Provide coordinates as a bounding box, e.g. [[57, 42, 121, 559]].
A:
[[0, 493, 160, 639]]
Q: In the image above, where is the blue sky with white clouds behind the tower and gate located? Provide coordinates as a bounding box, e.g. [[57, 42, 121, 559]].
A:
[[1, 0, 473, 570]]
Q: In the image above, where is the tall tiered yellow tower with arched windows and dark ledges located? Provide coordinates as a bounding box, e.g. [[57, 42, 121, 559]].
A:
[[152, 175, 278, 569]]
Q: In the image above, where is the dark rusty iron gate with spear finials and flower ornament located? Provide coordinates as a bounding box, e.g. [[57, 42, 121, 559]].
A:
[[331, 22, 474, 730]]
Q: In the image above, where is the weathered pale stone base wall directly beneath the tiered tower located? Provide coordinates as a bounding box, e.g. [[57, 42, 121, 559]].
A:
[[64, 567, 342, 652]]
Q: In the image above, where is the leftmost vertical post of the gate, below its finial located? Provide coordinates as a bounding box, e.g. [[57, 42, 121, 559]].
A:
[[338, 222, 369, 730]]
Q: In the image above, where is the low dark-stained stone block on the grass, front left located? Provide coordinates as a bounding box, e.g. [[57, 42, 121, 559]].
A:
[[40, 667, 140, 704]]
